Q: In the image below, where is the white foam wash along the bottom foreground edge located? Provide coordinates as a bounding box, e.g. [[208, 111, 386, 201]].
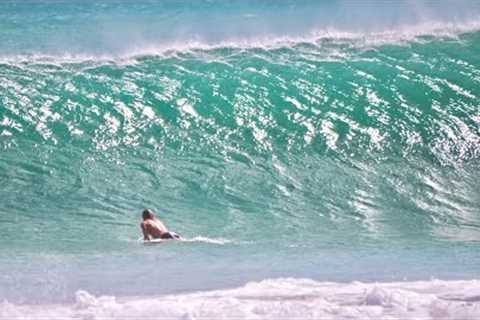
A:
[[0, 279, 480, 320]]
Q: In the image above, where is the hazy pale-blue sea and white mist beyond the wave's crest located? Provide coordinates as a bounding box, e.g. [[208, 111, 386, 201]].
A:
[[0, 0, 480, 56]]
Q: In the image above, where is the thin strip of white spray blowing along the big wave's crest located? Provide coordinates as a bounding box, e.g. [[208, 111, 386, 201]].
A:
[[0, 17, 480, 65]]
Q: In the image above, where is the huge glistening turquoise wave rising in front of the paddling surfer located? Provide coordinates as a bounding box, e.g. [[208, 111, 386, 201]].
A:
[[0, 32, 480, 255]]
